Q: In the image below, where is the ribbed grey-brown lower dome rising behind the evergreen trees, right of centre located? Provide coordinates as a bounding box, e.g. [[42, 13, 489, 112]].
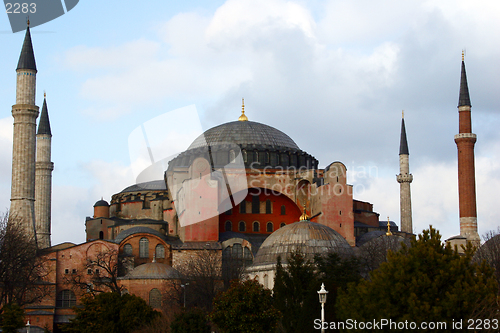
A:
[[253, 220, 354, 265]]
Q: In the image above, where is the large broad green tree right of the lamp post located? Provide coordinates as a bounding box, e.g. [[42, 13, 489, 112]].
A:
[[337, 227, 497, 326]]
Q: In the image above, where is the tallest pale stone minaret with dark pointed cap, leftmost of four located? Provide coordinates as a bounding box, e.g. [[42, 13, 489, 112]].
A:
[[9, 21, 38, 236]]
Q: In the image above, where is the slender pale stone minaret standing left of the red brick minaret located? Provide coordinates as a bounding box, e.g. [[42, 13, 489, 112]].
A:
[[397, 111, 413, 233]]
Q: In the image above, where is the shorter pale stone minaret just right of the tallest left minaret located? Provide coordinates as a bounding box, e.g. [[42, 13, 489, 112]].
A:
[[35, 93, 54, 249]]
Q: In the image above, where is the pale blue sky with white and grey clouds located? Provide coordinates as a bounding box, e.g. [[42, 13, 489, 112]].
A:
[[0, 0, 500, 244]]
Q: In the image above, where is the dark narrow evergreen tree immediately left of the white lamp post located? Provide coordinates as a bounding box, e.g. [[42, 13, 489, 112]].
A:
[[273, 252, 321, 333]]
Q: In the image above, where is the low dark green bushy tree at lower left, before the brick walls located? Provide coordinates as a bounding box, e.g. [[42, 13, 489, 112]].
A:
[[63, 293, 159, 333]]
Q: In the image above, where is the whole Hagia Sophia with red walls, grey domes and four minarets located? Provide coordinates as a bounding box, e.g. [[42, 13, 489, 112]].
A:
[[4, 26, 479, 332]]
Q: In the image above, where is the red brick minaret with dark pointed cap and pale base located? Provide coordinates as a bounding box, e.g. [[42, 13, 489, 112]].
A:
[[455, 52, 480, 242]]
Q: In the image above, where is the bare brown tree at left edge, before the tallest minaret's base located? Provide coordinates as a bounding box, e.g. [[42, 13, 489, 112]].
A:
[[0, 213, 49, 306]]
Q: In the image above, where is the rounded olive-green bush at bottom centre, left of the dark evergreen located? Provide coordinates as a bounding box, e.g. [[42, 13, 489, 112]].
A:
[[210, 280, 281, 333]]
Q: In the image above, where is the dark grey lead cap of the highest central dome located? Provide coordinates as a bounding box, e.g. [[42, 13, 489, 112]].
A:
[[188, 121, 299, 150]]
